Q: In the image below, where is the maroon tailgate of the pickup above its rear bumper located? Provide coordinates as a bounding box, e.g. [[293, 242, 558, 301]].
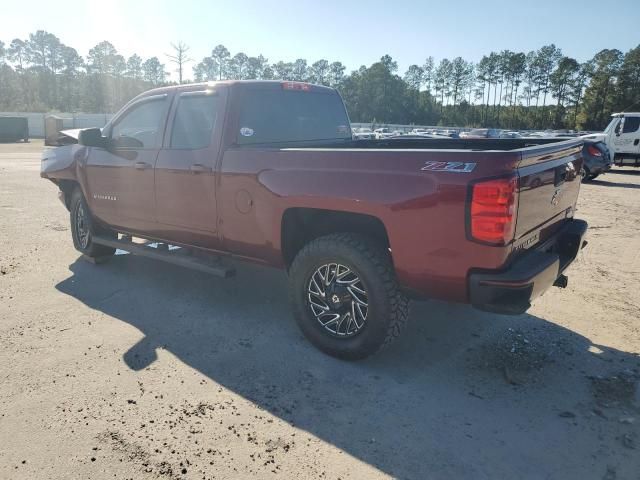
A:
[[514, 140, 583, 249]]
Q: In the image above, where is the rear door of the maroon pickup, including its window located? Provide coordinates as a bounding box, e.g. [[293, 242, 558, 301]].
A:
[[155, 89, 226, 248]]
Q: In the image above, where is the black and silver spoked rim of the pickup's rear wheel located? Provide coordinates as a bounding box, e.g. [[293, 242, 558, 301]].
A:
[[307, 263, 369, 338]]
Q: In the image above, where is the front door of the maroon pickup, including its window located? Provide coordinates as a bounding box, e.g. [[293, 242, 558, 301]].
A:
[[86, 94, 170, 230]]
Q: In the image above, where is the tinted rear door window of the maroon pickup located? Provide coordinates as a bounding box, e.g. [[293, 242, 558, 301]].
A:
[[170, 93, 219, 150]]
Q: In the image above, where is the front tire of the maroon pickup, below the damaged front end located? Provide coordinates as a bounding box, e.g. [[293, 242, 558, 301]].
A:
[[69, 188, 117, 258]]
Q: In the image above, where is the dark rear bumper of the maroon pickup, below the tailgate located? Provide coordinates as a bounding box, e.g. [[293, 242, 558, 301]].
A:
[[469, 220, 587, 315]]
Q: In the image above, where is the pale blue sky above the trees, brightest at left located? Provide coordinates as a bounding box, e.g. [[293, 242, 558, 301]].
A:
[[0, 0, 640, 78]]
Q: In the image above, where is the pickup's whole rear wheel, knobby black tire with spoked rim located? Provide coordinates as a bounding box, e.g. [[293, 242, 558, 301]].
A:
[[289, 233, 409, 360]]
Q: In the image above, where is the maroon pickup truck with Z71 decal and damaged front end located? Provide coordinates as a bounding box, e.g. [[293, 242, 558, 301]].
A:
[[41, 81, 587, 359]]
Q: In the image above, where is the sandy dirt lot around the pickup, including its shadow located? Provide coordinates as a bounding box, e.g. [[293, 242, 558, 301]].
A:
[[0, 141, 640, 480]]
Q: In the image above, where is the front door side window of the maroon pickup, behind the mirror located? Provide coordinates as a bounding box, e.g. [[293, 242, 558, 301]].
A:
[[111, 98, 167, 148]]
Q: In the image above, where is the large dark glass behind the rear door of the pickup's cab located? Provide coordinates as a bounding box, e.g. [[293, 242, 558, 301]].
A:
[[237, 89, 351, 145]]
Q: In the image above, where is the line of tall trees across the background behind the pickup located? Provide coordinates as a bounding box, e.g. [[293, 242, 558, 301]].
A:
[[0, 30, 640, 130]]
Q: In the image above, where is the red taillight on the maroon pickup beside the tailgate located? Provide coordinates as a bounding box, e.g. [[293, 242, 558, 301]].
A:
[[470, 177, 518, 245]]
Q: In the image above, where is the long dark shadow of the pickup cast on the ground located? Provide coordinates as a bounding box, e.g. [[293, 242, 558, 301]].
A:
[[57, 255, 640, 479]]
